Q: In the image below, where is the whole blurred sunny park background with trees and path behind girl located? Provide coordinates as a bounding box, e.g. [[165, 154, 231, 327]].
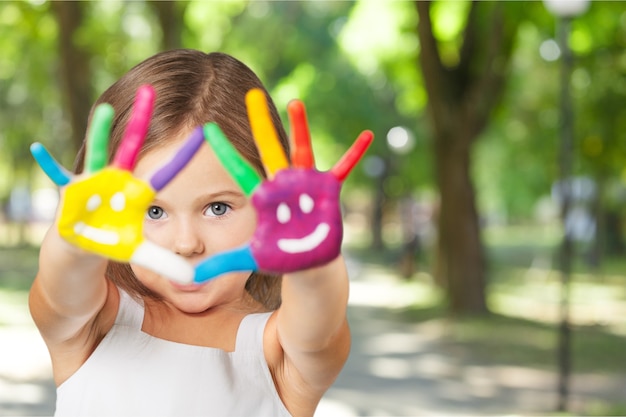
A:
[[0, 0, 626, 416]]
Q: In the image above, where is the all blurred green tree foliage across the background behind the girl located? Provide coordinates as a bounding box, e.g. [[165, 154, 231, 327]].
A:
[[0, 0, 626, 312]]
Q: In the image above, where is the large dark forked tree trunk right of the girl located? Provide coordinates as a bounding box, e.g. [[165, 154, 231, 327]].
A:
[[415, 0, 521, 313]]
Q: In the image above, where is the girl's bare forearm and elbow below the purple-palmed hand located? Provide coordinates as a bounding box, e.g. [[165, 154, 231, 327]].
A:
[[265, 256, 350, 415]]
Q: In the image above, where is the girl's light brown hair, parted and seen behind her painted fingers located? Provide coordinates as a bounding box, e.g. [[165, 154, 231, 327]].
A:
[[75, 49, 289, 310]]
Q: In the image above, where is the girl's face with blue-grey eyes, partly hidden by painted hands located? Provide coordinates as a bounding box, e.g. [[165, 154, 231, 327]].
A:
[[132, 132, 256, 313]]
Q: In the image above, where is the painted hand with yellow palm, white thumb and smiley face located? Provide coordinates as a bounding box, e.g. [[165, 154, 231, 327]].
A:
[[31, 85, 204, 283]]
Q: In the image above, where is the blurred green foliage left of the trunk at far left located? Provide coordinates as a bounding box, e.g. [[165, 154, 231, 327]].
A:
[[0, 2, 60, 187]]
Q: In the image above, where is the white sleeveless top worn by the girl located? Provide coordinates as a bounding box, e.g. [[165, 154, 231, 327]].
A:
[[55, 290, 290, 417]]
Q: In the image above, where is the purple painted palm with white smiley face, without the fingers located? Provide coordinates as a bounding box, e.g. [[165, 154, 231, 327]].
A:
[[250, 169, 343, 272]]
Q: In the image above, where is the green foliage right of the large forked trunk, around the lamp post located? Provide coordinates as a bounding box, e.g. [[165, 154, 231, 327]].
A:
[[475, 2, 626, 220]]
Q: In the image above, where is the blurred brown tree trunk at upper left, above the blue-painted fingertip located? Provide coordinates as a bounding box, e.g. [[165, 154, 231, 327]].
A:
[[50, 1, 92, 154]]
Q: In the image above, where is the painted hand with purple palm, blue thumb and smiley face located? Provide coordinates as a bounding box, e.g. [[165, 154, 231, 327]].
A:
[[194, 89, 373, 282]]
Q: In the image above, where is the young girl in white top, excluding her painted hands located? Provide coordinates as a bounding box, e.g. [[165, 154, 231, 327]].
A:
[[30, 50, 350, 416]]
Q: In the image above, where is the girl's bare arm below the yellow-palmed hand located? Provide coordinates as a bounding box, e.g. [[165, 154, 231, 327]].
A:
[[29, 218, 119, 386]]
